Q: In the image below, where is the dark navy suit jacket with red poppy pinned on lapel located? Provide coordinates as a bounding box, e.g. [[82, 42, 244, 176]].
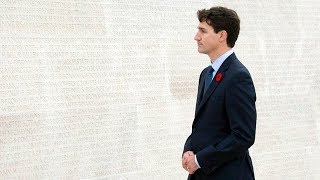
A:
[[183, 53, 257, 180]]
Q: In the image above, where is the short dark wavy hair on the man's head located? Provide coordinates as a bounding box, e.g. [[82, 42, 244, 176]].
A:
[[197, 6, 240, 48]]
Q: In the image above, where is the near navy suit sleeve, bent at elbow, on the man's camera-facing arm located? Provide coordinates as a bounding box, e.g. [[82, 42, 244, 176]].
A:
[[197, 72, 257, 174]]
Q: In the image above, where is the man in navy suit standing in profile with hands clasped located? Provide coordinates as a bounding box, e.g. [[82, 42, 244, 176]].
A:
[[182, 7, 256, 180]]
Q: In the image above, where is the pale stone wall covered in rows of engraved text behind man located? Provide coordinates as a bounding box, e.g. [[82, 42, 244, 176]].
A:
[[0, 0, 320, 180]]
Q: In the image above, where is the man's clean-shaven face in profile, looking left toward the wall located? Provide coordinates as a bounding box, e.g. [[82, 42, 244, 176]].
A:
[[194, 21, 221, 55]]
